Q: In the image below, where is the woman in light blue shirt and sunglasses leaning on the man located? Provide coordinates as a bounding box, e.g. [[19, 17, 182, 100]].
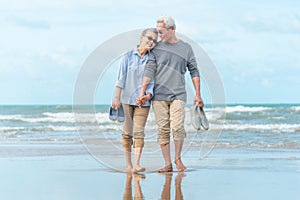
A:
[[111, 28, 158, 172]]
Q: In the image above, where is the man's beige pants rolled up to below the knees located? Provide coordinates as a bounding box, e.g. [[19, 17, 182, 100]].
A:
[[152, 100, 186, 144]]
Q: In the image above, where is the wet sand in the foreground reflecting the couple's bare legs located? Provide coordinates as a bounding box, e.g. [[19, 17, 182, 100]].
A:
[[0, 144, 300, 200]]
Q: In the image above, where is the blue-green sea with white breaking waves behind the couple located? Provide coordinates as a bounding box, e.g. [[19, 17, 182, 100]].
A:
[[0, 104, 300, 149]]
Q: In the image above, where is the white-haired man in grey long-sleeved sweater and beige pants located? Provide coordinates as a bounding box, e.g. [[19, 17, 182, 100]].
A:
[[137, 16, 204, 173]]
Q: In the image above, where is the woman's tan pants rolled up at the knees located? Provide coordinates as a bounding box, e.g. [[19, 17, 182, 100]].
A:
[[122, 104, 150, 147]]
